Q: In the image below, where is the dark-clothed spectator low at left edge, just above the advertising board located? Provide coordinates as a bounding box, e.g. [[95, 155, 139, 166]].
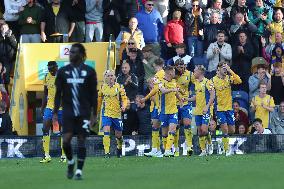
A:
[[0, 101, 13, 135]]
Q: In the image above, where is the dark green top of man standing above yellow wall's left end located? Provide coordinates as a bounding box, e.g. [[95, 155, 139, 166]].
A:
[[18, 4, 43, 34]]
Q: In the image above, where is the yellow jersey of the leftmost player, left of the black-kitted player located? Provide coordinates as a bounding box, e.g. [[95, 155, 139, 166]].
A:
[[43, 73, 56, 110]]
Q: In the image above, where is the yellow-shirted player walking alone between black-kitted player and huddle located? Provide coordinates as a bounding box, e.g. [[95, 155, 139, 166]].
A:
[[98, 70, 128, 158]]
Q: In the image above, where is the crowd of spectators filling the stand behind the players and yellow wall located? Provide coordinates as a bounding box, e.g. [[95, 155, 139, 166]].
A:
[[0, 0, 284, 135]]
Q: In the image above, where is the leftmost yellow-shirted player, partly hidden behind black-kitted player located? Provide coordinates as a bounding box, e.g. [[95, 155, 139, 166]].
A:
[[40, 61, 66, 163]]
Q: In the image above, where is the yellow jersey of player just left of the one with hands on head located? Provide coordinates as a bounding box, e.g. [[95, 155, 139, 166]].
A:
[[194, 77, 214, 115]]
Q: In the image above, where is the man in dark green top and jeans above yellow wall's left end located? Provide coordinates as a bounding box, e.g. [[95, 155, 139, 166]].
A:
[[19, 0, 43, 43]]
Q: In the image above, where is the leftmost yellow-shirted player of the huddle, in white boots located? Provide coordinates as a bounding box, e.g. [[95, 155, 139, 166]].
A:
[[141, 58, 165, 157]]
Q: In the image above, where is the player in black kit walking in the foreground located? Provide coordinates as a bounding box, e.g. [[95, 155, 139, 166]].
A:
[[53, 43, 98, 180]]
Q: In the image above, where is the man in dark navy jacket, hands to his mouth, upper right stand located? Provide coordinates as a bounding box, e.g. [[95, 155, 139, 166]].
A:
[[230, 13, 257, 45]]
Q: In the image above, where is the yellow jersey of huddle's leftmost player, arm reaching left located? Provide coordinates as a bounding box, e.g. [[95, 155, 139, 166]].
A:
[[145, 69, 165, 112]]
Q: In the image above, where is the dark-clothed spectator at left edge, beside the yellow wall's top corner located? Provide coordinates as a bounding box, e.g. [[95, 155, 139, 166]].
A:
[[0, 24, 17, 88]]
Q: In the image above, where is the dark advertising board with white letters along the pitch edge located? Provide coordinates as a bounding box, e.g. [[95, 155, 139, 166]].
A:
[[0, 135, 284, 159]]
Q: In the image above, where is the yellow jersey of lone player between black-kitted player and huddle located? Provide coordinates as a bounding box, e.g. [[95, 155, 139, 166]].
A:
[[98, 83, 127, 119]]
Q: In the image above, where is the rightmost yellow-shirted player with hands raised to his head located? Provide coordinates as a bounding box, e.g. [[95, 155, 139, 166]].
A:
[[211, 62, 242, 156]]
